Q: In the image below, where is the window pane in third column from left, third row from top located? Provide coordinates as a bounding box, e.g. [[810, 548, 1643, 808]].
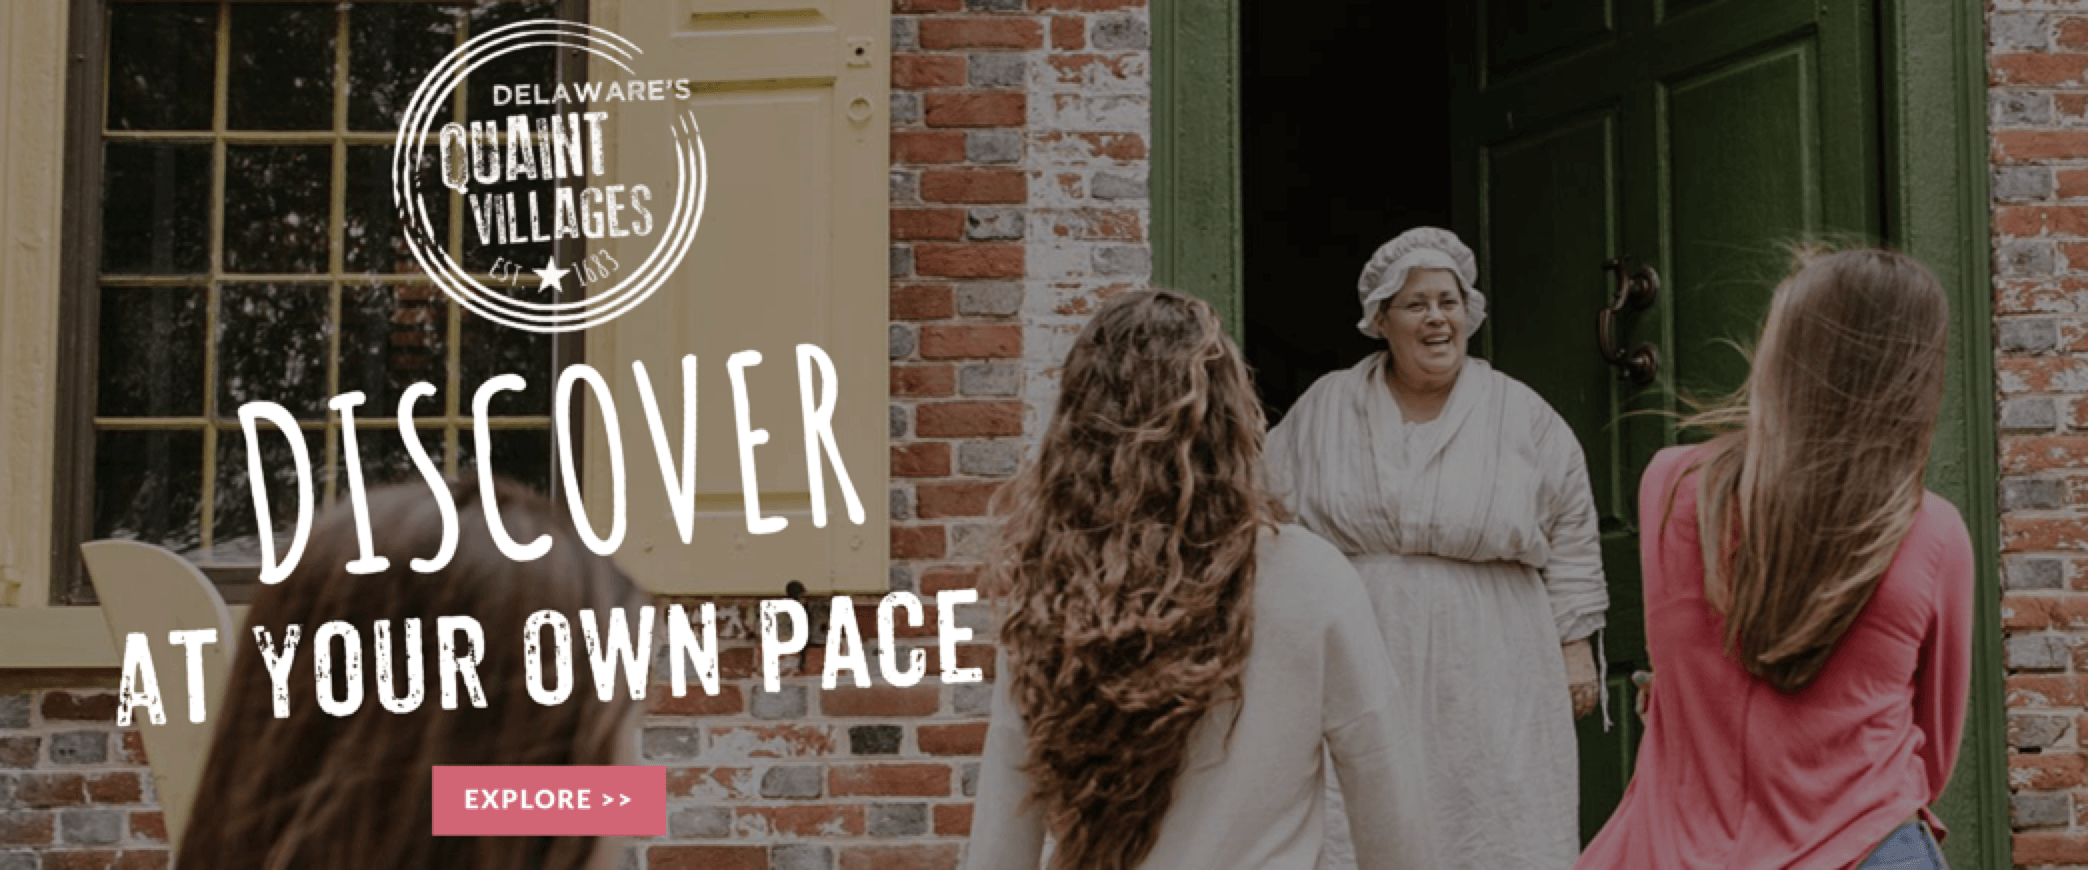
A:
[[340, 286, 449, 411]]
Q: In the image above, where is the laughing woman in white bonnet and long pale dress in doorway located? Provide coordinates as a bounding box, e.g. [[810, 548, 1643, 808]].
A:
[[1267, 227, 1610, 870]]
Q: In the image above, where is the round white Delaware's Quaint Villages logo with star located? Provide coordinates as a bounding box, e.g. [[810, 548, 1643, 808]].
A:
[[390, 19, 710, 334]]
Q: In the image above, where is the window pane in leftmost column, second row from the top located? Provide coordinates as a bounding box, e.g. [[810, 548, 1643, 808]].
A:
[[102, 142, 211, 275]]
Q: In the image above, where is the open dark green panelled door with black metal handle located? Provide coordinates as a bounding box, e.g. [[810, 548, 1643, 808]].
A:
[[1451, 0, 2004, 866]]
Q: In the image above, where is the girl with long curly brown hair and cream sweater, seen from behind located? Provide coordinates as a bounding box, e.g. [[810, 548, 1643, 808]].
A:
[[967, 290, 1434, 870]]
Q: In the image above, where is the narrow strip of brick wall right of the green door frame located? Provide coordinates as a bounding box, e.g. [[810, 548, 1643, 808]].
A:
[[1988, 0, 2088, 866]]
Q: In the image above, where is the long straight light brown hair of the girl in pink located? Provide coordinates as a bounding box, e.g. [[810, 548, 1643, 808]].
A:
[[1685, 250, 1950, 693]]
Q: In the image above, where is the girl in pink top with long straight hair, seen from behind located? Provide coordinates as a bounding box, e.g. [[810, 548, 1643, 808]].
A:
[[1576, 250, 1973, 870]]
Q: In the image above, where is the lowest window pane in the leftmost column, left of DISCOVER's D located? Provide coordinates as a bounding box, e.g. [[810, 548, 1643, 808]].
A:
[[94, 430, 203, 553]]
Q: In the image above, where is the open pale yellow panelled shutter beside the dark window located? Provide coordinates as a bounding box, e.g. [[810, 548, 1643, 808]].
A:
[[583, 0, 892, 597]]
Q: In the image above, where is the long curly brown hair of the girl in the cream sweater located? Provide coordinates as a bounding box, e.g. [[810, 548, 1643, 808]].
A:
[[992, 290, 1284, 870]]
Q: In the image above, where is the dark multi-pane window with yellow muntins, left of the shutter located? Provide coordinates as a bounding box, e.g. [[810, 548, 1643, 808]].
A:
[[63, 2, 578, 603]]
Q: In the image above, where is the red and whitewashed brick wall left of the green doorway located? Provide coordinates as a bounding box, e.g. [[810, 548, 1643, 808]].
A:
[[0, 0, 1150, 870]]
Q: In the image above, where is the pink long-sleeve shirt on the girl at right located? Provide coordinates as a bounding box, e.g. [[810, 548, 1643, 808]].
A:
[[1576, 446, 1973, 870]]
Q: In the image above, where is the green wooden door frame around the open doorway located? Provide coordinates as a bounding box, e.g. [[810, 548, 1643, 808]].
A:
[[1150, 0, 2013, 870]]
